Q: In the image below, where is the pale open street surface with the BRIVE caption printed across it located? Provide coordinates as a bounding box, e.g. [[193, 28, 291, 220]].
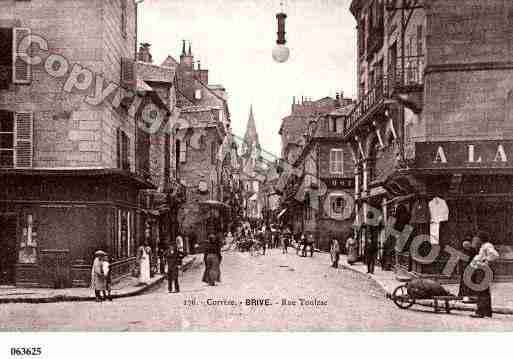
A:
[[4, 250, 513, 331]]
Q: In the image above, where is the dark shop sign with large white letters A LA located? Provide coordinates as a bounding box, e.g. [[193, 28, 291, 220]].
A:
[[415, 140, 513, 169]]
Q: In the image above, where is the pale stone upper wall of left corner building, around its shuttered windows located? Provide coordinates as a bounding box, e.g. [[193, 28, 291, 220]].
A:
[[0, 0, 135, 168]]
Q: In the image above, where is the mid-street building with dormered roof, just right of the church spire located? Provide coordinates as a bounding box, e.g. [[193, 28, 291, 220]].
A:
[[280, 94, 354, 249]]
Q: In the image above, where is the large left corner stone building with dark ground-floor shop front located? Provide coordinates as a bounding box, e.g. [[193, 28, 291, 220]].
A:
[[0, 0, 179, 287]]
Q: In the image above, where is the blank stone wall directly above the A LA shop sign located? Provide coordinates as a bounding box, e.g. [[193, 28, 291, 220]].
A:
[[423, 0, 513, 141]]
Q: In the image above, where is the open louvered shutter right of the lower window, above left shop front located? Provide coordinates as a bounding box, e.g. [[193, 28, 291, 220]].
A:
[[14, 112, 34, 168]]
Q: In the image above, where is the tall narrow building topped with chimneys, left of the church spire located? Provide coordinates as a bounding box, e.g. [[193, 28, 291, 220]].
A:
[[162, 42, 237, 243]]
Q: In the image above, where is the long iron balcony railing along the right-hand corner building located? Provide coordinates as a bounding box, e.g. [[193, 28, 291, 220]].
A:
[[344, 56, 424, 136]]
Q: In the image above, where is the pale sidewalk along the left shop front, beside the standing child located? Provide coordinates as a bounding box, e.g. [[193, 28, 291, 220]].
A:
[[0, 255, 200, 303]]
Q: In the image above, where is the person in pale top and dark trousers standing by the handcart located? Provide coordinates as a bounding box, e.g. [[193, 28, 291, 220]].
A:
[[470, 232, 499, 318]]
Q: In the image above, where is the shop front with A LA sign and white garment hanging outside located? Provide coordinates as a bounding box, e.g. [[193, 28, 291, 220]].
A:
[[389, 140, 513, 281]]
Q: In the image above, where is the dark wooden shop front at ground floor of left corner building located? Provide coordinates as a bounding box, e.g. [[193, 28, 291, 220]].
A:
[[0, 170, 156, 288]]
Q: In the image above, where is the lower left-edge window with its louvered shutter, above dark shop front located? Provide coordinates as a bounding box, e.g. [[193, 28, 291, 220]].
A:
[[0, 111, 33, 168]]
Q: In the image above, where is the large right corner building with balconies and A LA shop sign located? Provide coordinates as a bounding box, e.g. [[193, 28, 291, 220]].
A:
[[344, 0, 513, 279]]
